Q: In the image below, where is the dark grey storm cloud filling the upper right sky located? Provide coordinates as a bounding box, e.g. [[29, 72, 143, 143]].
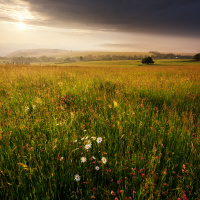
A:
[[22, 0, 200, 36]]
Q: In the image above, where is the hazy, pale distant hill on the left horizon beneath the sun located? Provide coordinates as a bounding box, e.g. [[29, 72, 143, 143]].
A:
[[7, 49, 69, 57]]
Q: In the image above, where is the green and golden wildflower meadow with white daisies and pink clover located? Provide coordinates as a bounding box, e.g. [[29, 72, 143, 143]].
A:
[[0, 60, 200, 200]]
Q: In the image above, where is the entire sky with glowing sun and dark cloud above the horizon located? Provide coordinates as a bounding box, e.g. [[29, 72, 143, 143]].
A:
[[0, 0, 200, 55]]
